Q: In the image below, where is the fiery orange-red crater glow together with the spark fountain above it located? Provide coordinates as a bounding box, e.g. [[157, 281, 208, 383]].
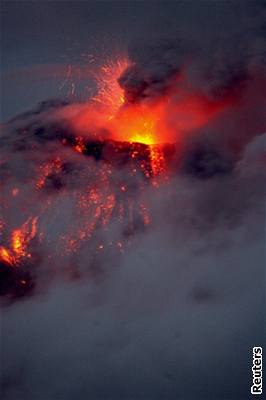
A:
[[72, 53, 239, 147]]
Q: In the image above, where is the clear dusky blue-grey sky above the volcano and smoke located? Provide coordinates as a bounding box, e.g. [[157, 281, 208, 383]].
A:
[[1, 1, 260, 120]]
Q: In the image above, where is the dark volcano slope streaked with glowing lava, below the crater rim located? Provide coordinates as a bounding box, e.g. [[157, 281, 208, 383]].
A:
[[0, 101, 179, 301]]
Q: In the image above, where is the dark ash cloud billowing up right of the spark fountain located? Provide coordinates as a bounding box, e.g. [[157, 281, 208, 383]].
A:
[[119, 2, 266, 103]]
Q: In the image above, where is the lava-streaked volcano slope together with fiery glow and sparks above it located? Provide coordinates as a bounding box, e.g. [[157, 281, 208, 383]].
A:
[[0, 54, 241, 296]]
